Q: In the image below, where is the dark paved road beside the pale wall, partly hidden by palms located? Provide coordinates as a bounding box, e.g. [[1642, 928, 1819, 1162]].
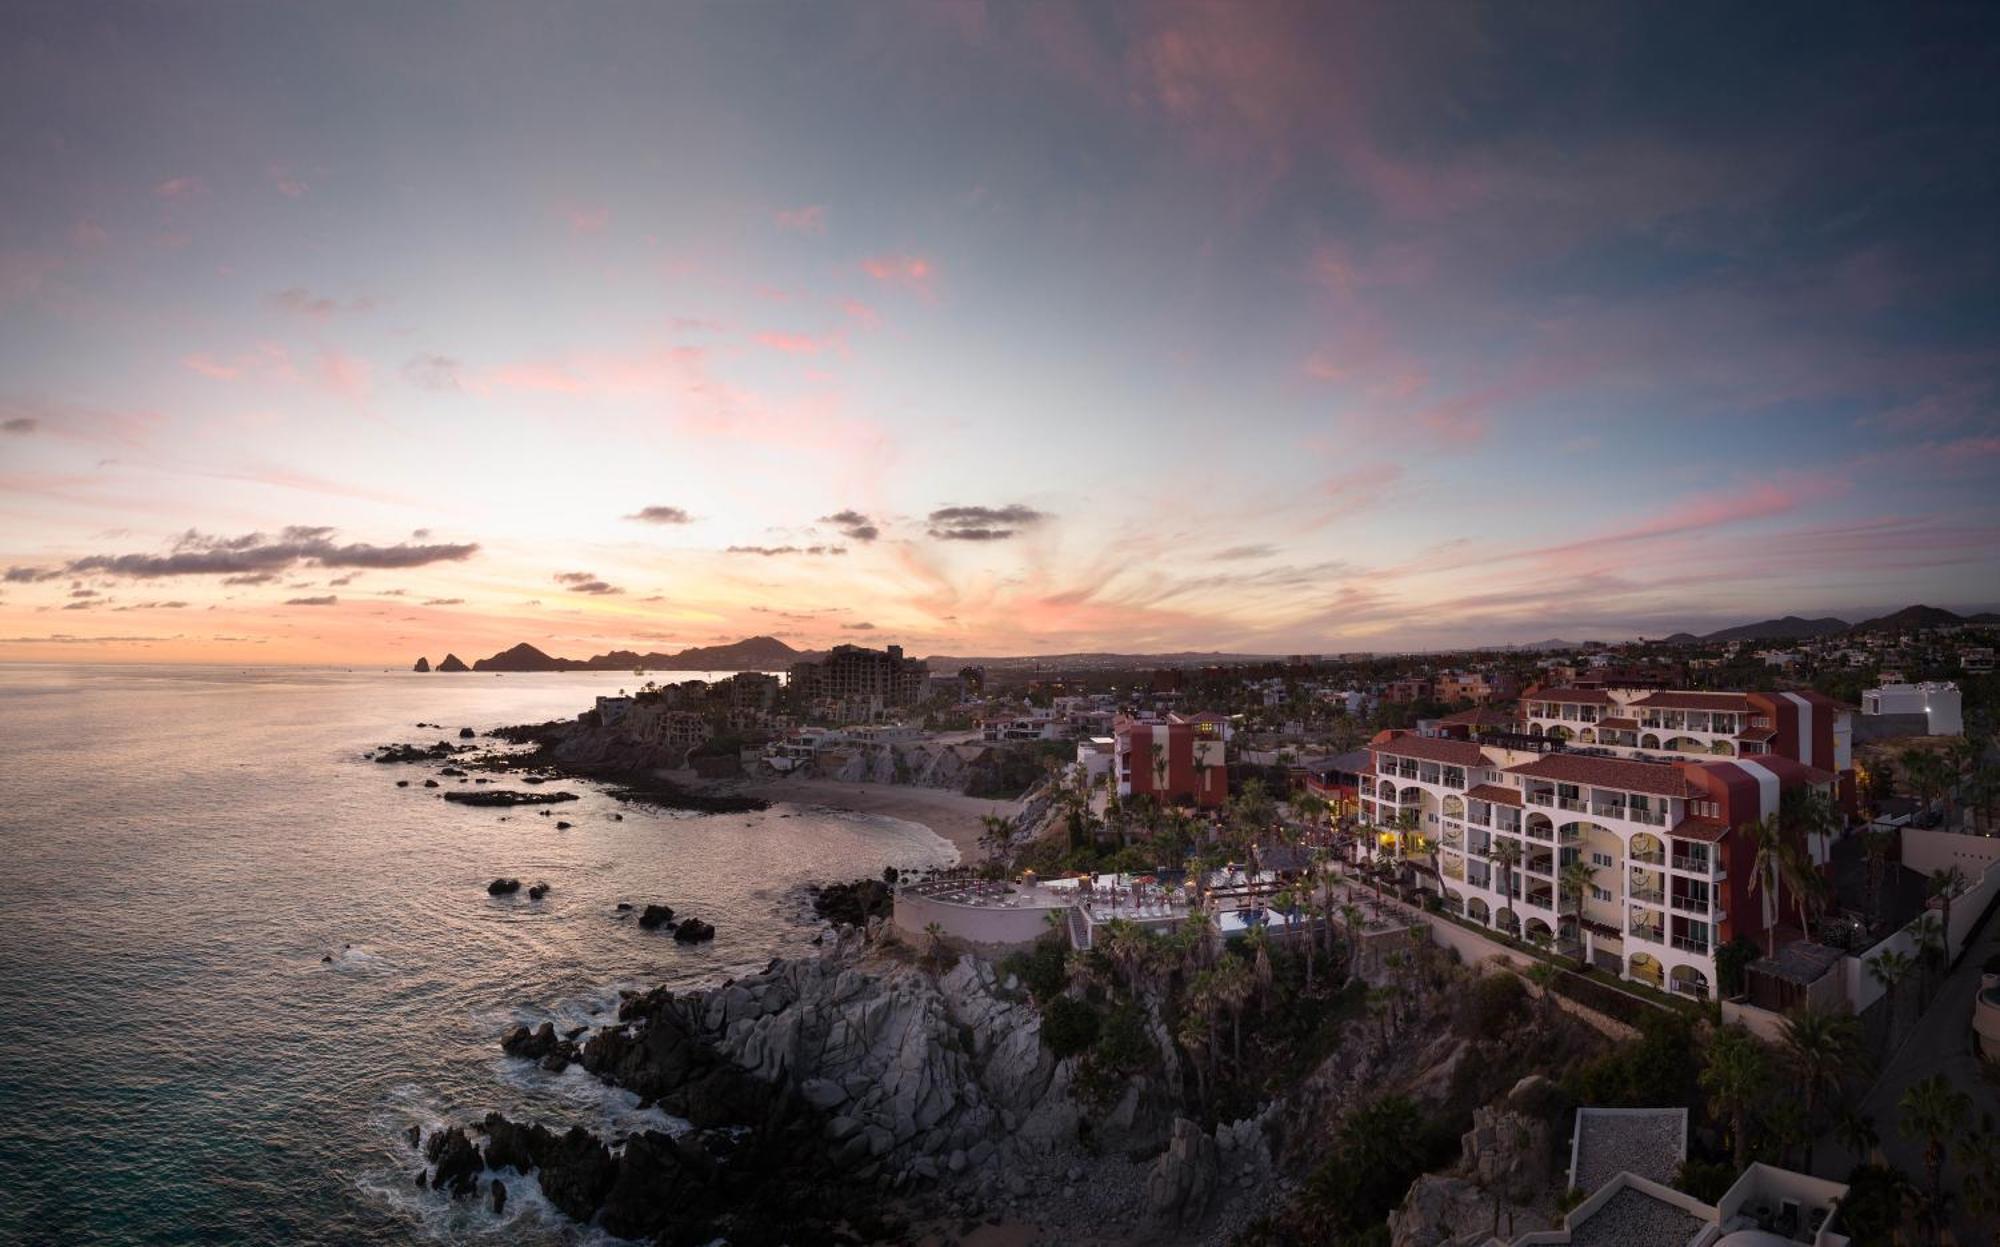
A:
[[1814, 899, 2000, 1243]]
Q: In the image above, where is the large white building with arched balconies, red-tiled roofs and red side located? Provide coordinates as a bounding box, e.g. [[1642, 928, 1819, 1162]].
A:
[[1360, 731, 1836, 997]]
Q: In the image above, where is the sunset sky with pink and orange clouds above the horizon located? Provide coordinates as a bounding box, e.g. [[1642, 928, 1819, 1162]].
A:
[[0, 2, 2000, 665]]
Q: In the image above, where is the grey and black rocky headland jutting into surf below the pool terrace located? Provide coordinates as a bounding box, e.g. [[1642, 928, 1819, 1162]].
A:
[[424, 923, 1270, 1243]]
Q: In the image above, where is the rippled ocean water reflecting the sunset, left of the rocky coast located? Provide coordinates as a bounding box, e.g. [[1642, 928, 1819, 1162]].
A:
[[0, 665, 956, 1243]]
